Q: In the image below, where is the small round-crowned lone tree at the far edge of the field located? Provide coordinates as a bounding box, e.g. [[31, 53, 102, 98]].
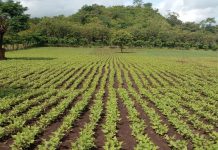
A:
[[112, 30, 132, 53]]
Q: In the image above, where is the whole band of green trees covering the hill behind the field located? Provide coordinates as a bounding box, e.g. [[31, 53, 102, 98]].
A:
[[0, 0, 218, 57]]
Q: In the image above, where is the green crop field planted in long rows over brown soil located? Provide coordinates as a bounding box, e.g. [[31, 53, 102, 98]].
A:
[[0, 48, 218, 150]]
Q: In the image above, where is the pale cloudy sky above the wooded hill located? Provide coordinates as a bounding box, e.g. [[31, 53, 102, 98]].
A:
[[12, 0, 218, 22]]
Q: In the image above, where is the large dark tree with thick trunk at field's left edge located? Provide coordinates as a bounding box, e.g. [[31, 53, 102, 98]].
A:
[[0, 0, 29, 60]]
